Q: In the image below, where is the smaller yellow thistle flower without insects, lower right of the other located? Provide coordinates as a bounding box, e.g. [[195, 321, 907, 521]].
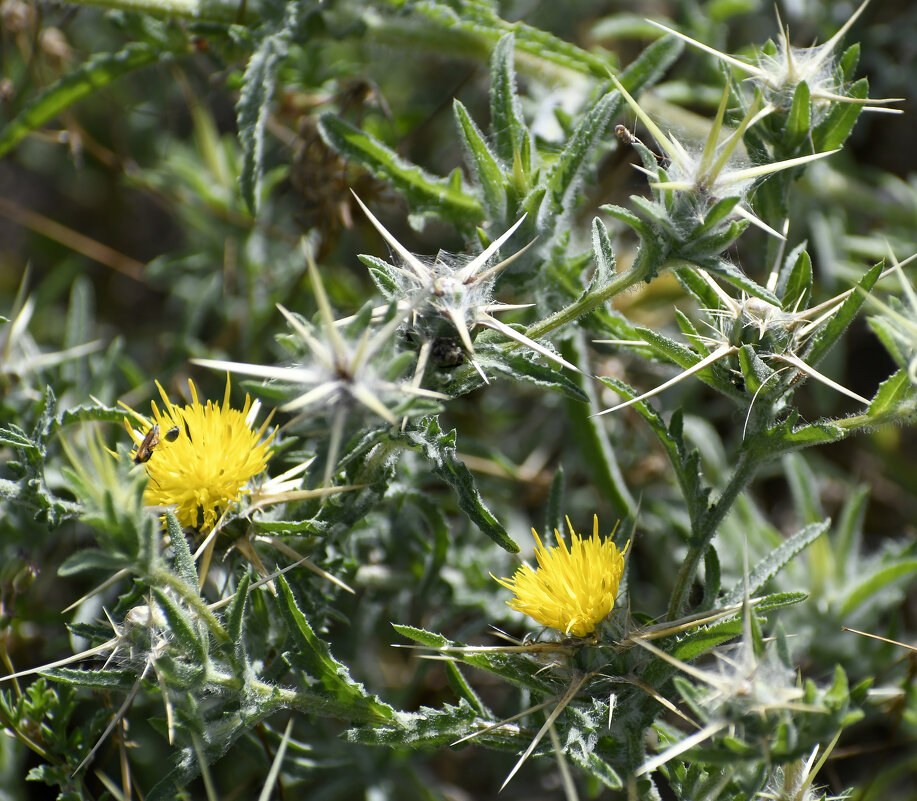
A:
[[494, 516, 630, 637]]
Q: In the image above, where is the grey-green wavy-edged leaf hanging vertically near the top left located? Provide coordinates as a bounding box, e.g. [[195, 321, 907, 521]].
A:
[[236, 30, 290, 213]]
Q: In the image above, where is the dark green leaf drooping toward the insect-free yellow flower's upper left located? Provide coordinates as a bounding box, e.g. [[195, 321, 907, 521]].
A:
[[407, 417, 519, 553]]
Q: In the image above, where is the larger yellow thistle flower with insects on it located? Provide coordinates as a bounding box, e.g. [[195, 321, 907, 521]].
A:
[[125, 376, 274, 530]]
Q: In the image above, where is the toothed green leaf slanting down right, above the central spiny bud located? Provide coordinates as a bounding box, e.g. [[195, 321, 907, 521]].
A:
[[318, 114, 484, 226]]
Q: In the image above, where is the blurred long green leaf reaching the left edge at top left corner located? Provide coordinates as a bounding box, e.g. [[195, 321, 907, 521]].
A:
[[0, 42, 166, 158]]
